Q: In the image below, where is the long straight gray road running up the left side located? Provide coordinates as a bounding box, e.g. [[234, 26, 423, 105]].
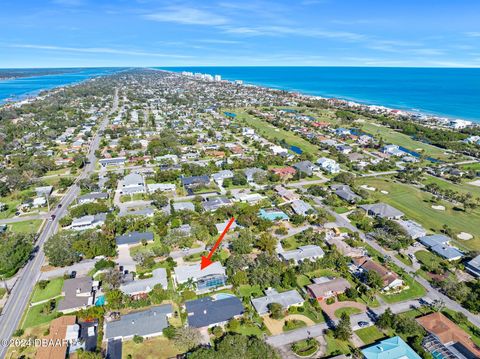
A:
[[0, 91, 118, 358]]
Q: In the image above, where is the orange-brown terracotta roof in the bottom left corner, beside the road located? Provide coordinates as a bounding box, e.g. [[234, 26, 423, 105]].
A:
[[35, 315, 77, 359]]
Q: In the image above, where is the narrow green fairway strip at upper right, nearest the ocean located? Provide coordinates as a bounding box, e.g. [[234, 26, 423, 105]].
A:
[[362, 122, 449, 161]]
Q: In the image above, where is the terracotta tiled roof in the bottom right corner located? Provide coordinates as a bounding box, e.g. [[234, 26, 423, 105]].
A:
[[417, 312, 480, 358]]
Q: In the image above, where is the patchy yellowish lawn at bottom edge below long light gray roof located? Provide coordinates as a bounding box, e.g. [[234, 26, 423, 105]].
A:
[[122, 336, 182, 359]]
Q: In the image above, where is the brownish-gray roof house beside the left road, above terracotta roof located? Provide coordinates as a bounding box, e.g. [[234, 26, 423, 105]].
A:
[[57, 277, 98, 313]]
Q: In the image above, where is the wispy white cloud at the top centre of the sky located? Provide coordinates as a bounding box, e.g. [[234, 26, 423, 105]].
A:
[[145, 7, 228, 26]]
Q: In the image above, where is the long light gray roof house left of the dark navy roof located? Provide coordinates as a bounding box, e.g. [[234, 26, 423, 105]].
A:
[[103, 304, 173, 341]]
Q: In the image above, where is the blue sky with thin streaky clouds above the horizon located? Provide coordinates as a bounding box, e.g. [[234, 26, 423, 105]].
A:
[[0, 0, 480, 67]]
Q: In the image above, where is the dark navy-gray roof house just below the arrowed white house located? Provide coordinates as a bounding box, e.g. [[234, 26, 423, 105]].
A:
[[185, 296, 245, 328]]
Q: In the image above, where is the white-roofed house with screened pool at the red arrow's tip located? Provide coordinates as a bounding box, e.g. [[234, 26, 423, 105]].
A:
[[173, 262, 227, 293]]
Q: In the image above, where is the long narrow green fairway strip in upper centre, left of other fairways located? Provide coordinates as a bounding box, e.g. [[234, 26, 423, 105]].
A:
[[236, 111, 319, 154]]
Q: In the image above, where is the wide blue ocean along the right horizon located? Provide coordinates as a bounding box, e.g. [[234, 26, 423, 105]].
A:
[[163, 67, 480, 122]]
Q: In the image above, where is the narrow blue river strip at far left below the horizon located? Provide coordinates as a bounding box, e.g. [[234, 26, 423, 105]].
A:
[[0, 68, 122, 104]]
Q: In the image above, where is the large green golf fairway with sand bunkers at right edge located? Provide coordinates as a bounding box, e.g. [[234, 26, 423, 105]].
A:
[[358, 178, 480, 250]]
